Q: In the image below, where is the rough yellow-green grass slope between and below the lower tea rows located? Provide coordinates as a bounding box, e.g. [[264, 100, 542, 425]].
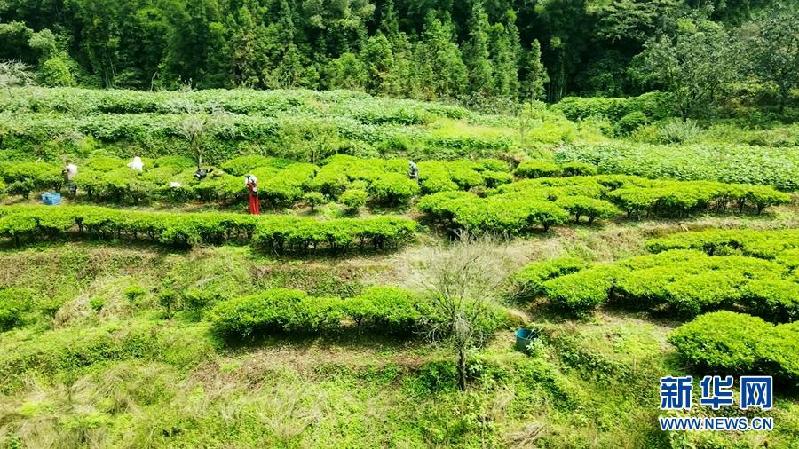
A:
[[0, 211, 799, 448]]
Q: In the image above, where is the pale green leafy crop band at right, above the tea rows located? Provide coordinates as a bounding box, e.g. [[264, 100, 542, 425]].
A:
[[556, 143, 799, 191]]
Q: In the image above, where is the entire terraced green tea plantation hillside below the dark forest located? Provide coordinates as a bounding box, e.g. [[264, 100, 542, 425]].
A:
[[0, 87, 799, 449]]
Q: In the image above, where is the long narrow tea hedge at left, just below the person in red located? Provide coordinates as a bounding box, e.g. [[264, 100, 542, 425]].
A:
[[0, 206, 416, 252]]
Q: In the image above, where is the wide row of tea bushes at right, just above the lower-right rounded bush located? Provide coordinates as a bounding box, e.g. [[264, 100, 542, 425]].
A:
[[515, 231, 799, 316]]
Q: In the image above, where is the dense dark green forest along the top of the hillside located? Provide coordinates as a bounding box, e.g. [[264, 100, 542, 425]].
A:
[[0, 0, 799, 109]]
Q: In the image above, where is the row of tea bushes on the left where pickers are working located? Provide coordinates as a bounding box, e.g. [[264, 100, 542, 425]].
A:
[[0, 155, 513, 211]]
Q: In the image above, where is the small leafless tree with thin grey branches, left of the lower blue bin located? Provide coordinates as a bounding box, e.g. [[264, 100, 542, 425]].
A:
[[413, 233, 511, 390]]
